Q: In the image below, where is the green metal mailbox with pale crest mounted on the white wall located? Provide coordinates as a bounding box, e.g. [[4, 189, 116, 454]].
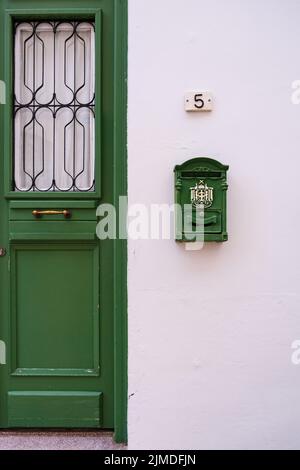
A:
[[174, 158, 229, 242]]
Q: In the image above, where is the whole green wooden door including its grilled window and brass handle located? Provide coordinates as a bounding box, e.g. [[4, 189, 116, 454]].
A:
[[0, 0, 114, 428]]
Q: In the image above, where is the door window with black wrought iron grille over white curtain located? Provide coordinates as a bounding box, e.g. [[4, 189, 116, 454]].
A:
[[13, 21, 95, 192]]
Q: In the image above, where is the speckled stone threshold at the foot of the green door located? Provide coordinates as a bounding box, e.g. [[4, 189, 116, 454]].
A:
[[0, 430, 126, 450]]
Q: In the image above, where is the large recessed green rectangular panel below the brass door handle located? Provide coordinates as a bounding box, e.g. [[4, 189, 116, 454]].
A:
[[11, 243, 100, 376]]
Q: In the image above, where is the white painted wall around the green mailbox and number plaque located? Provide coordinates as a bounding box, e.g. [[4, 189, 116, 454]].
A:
[[128, 0, 300, 449]]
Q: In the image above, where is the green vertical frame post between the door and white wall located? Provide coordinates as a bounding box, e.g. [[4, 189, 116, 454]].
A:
[[0, 0, 128, 442]]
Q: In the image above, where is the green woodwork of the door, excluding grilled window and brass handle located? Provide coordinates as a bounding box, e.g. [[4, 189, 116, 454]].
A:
[[0, 0, 117, 429]]
